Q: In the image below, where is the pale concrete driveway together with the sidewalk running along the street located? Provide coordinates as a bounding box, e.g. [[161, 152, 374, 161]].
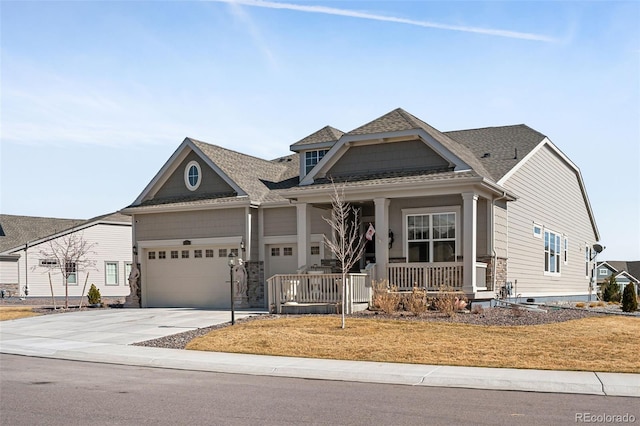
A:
[[0, 308, 640, 397]]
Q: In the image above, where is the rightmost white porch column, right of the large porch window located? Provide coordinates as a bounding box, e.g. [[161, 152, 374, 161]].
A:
[[462, 192, 478, 293]]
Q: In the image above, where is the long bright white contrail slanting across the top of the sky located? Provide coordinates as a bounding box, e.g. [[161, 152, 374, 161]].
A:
[[209, 0, 557, 42]]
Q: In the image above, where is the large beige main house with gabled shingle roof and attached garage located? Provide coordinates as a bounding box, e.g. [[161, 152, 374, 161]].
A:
[[123, 109, 599, 307]]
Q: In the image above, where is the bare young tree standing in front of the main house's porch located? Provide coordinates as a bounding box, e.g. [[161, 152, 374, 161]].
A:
[[323, 179, 366, 328]]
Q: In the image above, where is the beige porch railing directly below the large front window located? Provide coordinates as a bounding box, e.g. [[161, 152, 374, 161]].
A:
[[387, 262, 462, 291]]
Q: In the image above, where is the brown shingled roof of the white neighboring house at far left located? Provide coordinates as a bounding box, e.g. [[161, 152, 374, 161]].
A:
[[0, 213, 131, 253]]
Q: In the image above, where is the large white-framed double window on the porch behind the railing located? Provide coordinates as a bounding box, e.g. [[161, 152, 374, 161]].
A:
[[407, 212, 456, 262]]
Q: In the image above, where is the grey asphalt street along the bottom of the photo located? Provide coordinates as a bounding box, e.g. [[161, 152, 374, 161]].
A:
[[0, 354, 640, 426]]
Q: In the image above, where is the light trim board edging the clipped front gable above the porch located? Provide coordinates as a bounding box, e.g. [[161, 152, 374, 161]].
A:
[[300, 129, 471, 186]]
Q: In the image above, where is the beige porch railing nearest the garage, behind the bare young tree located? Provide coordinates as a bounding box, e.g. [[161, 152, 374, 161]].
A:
[[267, 273, 371, 313]]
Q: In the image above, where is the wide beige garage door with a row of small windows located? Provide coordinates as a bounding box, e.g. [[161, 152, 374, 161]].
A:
[[143, 246, 236, 308]]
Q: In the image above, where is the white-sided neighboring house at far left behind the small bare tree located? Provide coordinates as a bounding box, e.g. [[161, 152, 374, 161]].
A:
[[0, 213, 132, 300]]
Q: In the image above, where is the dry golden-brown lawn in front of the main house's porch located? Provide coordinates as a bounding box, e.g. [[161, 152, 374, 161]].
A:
[[187, 316, 640, 373]]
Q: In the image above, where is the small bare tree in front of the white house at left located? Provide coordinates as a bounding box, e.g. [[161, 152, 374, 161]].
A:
[[40, 232, 96, 309]]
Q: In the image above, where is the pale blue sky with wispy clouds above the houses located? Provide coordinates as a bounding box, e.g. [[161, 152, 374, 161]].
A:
[[0, 0, 640, 260]]
